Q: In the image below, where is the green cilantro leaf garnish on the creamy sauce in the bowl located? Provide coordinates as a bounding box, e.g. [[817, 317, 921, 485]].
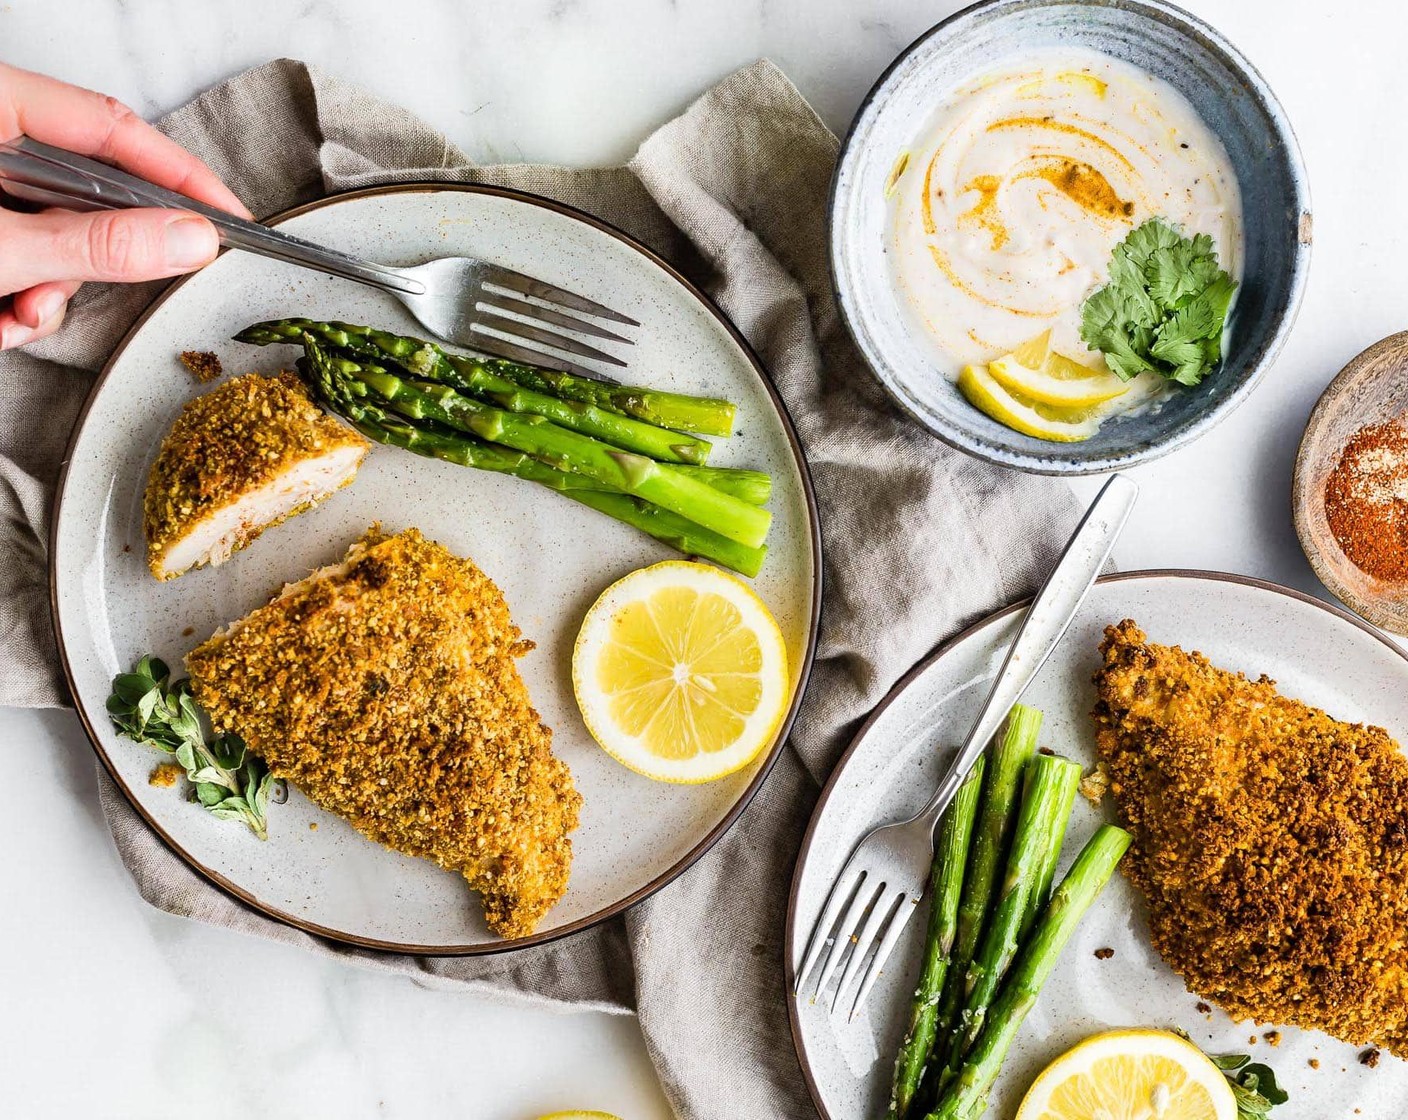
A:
[[1080, 218, 1236, 385]]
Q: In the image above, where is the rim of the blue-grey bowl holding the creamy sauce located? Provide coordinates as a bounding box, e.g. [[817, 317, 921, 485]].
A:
[[826, 0, 1314, 478]]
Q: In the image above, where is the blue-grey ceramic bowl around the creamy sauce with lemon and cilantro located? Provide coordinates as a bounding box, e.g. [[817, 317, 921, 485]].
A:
[[831, 0, 1311, 475]]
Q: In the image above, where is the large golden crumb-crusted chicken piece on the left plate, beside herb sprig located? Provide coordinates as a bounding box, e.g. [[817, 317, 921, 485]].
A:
[[186, 528, 582, 937]]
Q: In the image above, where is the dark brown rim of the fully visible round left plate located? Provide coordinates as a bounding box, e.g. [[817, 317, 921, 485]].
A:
[[46, 180, 824, 957]]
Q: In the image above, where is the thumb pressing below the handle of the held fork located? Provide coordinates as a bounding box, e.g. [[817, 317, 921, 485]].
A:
[[0, 210, 220, 292]]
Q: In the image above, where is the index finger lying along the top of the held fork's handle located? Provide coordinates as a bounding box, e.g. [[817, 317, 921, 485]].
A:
[[0, 66, 249, 218]]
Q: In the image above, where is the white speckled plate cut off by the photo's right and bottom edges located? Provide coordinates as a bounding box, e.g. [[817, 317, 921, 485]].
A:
[[786, 572, 1408, 1120]]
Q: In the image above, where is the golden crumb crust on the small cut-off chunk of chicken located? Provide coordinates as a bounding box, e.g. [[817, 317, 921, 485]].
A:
[[144, 373, 370, 579]]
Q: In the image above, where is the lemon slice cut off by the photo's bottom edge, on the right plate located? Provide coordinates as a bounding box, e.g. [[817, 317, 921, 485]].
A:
[[1017, 1030, 1236, 1120]]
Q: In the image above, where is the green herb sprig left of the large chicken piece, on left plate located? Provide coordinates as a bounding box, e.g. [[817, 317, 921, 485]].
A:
[[107, 657, 275, 840]]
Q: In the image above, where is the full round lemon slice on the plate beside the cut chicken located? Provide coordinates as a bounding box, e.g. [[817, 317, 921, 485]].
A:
[[572, 561, 790, 783]]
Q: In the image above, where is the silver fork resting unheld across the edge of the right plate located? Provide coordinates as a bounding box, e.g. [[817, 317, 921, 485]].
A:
[[793, 475, 1139, 1020]]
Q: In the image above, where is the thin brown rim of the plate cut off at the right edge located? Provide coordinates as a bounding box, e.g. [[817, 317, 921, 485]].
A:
[[783, 568, 1408, 1120]]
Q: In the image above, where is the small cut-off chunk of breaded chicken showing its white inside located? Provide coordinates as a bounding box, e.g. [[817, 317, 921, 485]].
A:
[[145, 373, 370, 579]]
